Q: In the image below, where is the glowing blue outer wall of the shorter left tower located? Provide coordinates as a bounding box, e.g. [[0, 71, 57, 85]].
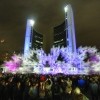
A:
[[24, 19, 34, 56]]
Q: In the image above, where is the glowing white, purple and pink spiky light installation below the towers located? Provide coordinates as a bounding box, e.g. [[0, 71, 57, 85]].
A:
[[4, 47, 100, 75]]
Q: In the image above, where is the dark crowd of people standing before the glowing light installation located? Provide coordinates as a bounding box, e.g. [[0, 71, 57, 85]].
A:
[[0, 73, 100, 100]]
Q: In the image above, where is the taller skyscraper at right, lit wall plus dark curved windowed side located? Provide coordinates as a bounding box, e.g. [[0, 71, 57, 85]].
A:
[[53, 5, 76, 52]]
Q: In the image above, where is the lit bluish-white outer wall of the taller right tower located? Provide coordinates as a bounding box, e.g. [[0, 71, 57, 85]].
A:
[[64, 5, 76, 52]]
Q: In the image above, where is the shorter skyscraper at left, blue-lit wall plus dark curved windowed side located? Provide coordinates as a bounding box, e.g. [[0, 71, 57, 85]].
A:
[[24, 19, 43, 56]]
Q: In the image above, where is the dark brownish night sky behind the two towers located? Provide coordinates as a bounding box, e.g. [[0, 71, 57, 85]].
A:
[[0, 0, 100, 52]]
